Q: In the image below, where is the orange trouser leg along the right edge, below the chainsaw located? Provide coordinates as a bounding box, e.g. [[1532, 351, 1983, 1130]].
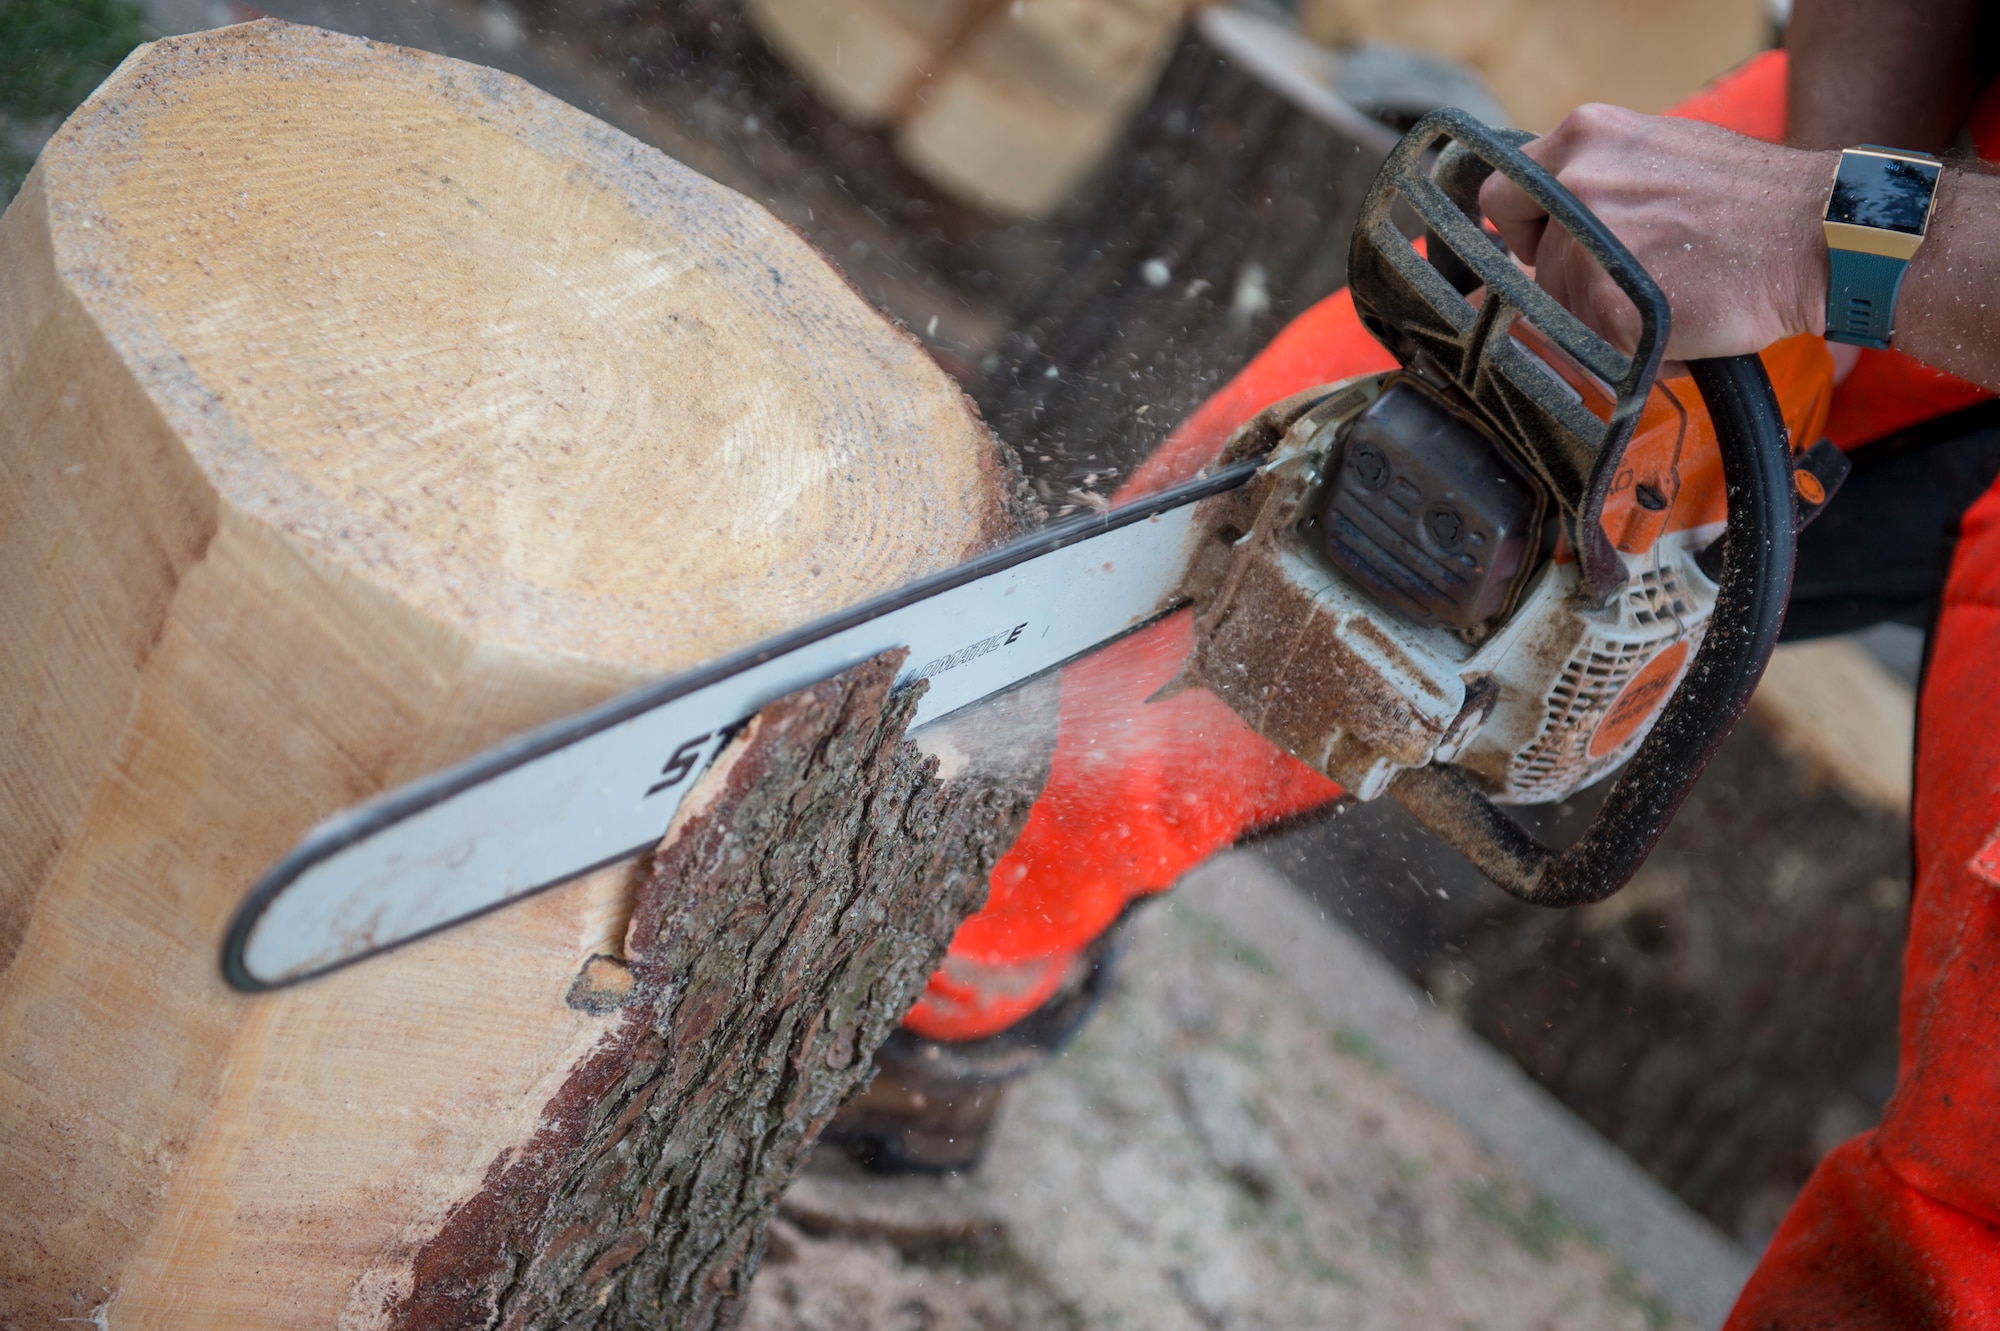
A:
[[1724, 535, 2000, 1331]]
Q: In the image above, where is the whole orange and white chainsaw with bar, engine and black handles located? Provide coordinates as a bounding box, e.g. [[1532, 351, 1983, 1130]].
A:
[[222, 110, 1840, 991]]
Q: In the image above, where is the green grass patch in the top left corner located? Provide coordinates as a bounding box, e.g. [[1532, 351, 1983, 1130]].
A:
[[0, 0, 152, 206]]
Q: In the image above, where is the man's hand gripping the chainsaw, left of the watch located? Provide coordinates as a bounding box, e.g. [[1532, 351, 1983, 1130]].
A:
[[1480, 106, 1836, 360]]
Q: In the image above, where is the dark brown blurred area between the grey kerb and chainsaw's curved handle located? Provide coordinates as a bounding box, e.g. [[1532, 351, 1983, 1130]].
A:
[[1260, 703, 1910, 1249]]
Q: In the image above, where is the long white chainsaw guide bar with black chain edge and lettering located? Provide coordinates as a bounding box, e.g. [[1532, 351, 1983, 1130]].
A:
[[222, 462, 1258, 991]]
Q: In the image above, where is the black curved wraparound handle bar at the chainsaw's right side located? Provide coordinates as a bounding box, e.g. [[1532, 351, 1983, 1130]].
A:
[[1390, 333, 1798, 905]]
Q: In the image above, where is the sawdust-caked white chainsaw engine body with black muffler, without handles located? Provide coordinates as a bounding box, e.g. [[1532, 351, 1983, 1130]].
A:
[[1184, 374, 1722, 803]]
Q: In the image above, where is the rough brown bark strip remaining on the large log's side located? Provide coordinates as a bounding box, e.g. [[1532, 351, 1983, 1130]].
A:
[[390, 654, 1036, 1331]]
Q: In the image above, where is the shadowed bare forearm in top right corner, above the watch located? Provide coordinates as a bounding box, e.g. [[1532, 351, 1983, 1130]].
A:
[[1784, 0, 1990, 152]]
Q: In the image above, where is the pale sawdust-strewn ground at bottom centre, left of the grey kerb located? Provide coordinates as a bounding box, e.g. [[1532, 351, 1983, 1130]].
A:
[[744, 859, 1692, 1331]]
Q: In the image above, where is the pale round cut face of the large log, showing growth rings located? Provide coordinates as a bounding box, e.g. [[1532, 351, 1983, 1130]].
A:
[[40, 20, 1004, 669]]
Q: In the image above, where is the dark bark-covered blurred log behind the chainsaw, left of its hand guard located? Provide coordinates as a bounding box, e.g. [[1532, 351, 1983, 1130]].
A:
[[974, 10, 1396, 516]]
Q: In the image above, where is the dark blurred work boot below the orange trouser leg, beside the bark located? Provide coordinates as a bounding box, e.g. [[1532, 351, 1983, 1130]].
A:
[[822, 907, 1132, 1173]]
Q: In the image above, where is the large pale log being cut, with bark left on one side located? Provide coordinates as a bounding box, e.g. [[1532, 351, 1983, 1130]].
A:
[[0, 22, 1032, 1327]]
